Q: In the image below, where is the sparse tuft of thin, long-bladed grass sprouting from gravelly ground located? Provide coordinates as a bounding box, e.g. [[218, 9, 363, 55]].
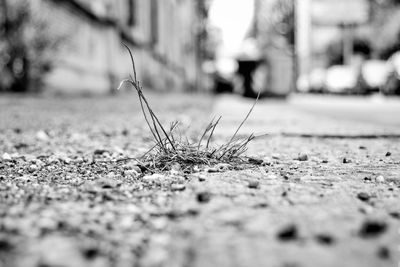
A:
[[119, 45, 259, 171]]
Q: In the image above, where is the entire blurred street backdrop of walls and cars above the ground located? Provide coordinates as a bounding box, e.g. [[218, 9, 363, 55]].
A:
[[0, 0, 400, 97]]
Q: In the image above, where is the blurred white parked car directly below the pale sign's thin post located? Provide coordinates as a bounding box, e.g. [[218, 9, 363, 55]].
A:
[[324, 65, 359, 94]]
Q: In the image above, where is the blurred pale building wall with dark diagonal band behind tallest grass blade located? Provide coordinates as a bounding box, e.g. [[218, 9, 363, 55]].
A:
[[31, 0, 200, 92]]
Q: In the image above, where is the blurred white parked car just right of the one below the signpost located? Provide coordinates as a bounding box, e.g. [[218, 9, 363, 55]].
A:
[[358, 60, 390, 93]]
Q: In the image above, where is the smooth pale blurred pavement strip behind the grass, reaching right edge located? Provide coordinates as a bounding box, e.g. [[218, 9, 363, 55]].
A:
[[212, 95, 400, 138]]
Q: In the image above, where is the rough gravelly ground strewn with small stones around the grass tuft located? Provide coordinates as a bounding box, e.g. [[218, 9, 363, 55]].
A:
[[0, 94, 400, 267]]
